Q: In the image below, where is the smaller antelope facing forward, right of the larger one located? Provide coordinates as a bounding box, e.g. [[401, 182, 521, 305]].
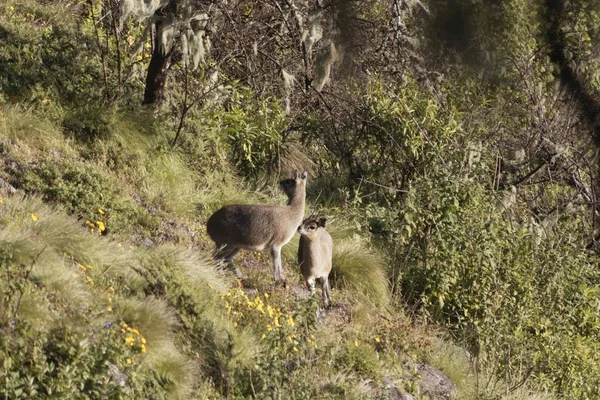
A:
[[298, 214, 333, 307]]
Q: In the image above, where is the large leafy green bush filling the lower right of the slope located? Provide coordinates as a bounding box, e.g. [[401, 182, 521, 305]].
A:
[[400, 173, 600, 398]]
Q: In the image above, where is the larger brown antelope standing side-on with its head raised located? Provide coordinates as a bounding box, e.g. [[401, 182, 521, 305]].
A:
[[206, 171, 308, 287]]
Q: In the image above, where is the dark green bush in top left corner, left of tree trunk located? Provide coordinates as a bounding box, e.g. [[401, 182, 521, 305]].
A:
[[0, 2, 103, 105]]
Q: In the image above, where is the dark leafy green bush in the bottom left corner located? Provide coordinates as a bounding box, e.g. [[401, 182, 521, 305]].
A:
[[0, 320, 166, 399]]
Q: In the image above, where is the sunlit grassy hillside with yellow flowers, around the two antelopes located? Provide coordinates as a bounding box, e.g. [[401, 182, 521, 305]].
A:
[[0, 111, 446, 399]]
